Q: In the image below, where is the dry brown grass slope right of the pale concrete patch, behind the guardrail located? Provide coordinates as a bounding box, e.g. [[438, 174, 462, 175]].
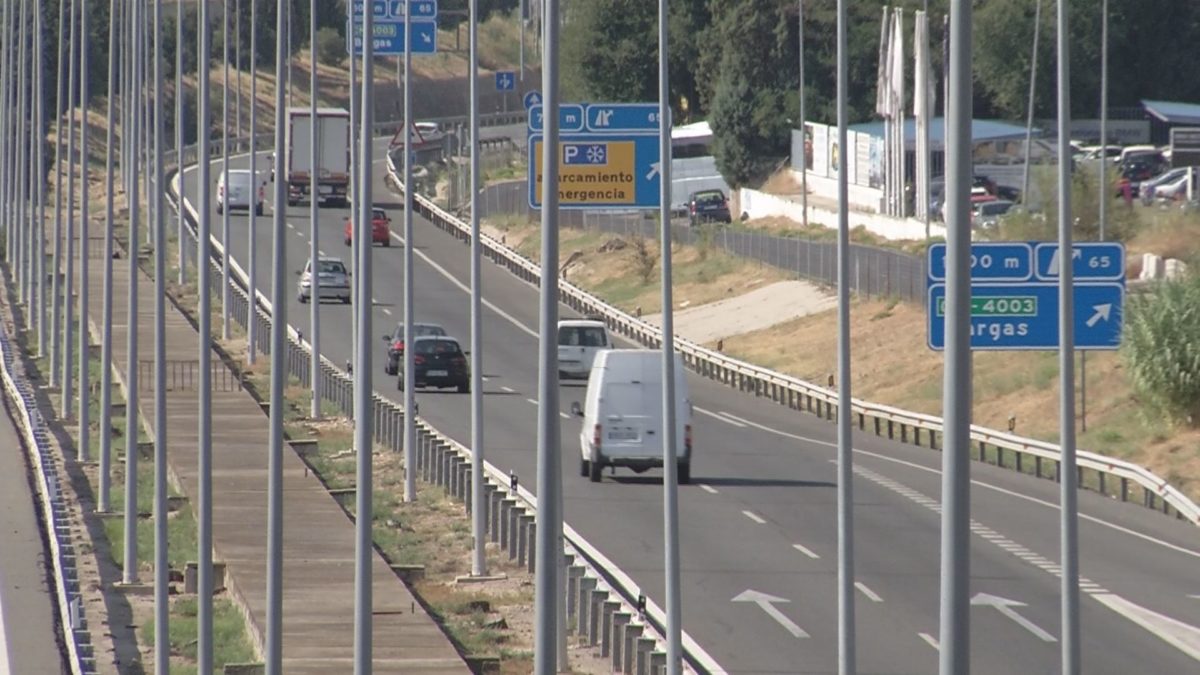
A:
[[725, 300, 1200, 496]]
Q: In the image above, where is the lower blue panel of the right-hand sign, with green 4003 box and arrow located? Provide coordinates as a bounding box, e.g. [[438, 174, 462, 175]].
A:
[[926, 282, 1124, 351]]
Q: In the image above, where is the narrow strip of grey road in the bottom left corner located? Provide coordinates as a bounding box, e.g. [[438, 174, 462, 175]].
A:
[[0, 400, 70, 675]]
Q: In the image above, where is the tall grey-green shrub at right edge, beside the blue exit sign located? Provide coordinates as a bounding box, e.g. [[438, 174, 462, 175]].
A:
[[1123, 268, 1200, 426]]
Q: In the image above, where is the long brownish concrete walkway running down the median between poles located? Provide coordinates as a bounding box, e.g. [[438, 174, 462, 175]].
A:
[[78, 239, 469, 674]]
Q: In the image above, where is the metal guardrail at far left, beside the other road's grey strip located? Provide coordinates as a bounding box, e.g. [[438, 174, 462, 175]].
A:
[[0, 327, 96, 675]]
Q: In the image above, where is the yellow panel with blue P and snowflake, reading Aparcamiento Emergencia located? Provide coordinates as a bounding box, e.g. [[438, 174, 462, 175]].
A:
[[533, 141, 637, 207]]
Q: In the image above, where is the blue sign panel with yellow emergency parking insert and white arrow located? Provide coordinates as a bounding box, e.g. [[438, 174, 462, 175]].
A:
[[528, 133, 662, 209]]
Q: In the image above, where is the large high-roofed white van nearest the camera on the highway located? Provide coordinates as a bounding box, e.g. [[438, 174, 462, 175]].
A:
[[571, 350, 691, 485]]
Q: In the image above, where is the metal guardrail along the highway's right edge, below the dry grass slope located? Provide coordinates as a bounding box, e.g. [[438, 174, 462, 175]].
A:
[[389, 154, 1200, 525]]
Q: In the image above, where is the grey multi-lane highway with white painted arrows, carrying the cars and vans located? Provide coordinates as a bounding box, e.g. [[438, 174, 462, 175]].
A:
[[180, 139, 1200, 675]]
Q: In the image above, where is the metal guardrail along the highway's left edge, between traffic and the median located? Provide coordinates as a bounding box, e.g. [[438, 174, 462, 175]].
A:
[[167, 138, 705, 675]]
